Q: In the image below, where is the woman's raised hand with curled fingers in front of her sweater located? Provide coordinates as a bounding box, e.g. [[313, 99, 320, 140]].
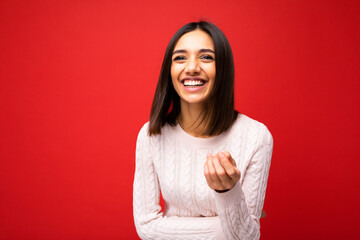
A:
[[204, 152, 240, 192]]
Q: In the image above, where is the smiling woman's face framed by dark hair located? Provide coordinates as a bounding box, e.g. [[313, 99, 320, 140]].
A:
[[171, 29, 216, 104]]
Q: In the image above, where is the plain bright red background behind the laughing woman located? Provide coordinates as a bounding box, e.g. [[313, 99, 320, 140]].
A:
[[0, 0, 360, 240]]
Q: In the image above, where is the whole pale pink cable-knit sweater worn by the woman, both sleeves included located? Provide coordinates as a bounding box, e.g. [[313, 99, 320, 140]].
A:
[[133, 114, 273, 240]]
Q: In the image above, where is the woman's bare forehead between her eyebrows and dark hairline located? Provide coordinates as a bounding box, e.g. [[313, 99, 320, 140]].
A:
[[174, 29, 215, 51]]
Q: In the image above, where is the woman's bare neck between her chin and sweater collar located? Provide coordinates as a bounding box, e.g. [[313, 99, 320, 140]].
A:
[[178, 101, 208, 137]]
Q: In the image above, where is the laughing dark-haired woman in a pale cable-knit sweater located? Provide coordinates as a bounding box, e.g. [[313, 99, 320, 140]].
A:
[[133, 22, 273, 239]]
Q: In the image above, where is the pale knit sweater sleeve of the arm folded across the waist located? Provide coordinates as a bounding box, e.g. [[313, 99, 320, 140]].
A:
[[133, 124, 224, 240]]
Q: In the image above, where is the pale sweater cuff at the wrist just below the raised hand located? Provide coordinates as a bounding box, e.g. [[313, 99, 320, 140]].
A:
[[214, 182, 244, 209]]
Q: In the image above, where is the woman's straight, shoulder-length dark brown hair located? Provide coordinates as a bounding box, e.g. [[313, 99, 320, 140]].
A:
[[149, 21, 238, 136]]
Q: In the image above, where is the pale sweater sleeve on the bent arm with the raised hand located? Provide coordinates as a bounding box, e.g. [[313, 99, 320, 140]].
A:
[[214, 126, 273, 240]]
